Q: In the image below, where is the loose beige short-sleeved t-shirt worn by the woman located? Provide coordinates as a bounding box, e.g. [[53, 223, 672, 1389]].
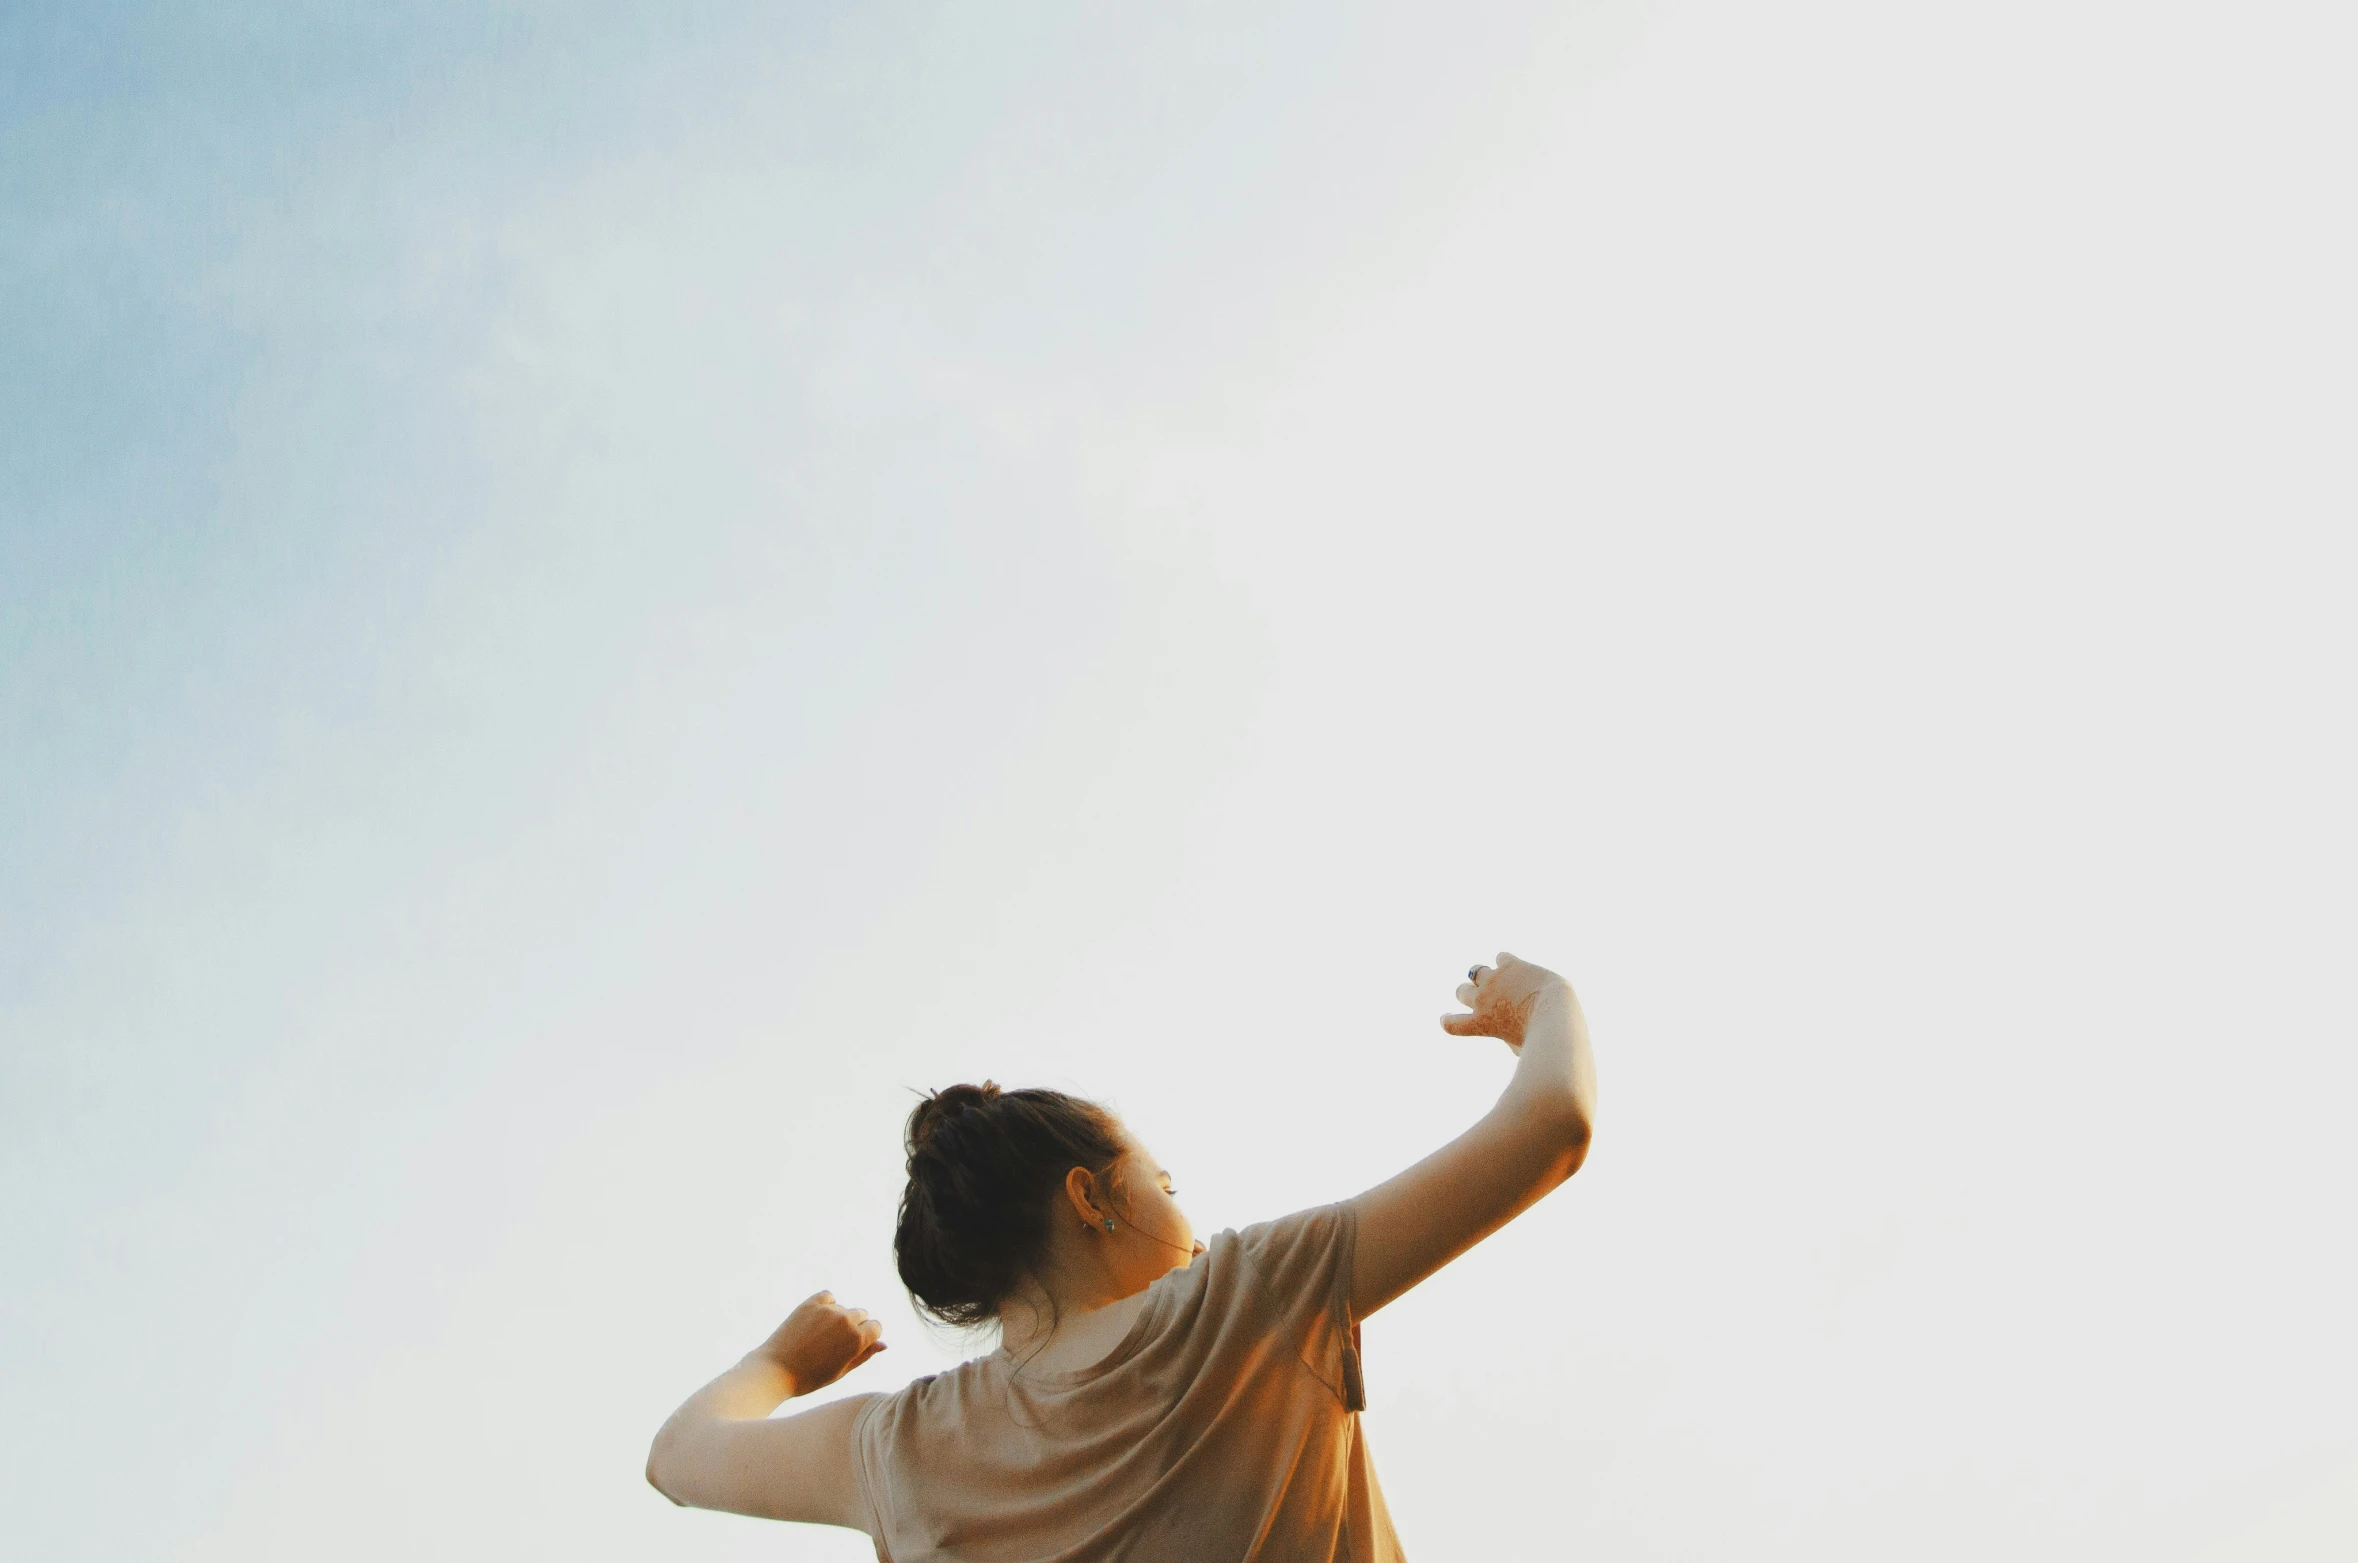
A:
[[851, 1205, 1401, 1563]]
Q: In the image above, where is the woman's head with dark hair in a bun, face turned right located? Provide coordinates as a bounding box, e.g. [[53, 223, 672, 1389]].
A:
[[894, 1080, 1193, 1325]]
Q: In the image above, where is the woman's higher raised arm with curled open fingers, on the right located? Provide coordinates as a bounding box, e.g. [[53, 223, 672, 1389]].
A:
[[1351, 955, 1596, 1318]]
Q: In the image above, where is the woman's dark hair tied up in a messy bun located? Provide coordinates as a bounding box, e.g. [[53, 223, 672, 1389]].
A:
[[891, 1080, 1125, 1325]]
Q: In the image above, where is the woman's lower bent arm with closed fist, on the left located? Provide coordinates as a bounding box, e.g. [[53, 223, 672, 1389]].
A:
[[646, 1292, 884, 1530]]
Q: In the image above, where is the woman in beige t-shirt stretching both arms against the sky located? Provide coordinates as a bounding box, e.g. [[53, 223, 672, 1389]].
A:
[[646, 955, 1596, 1563]]
